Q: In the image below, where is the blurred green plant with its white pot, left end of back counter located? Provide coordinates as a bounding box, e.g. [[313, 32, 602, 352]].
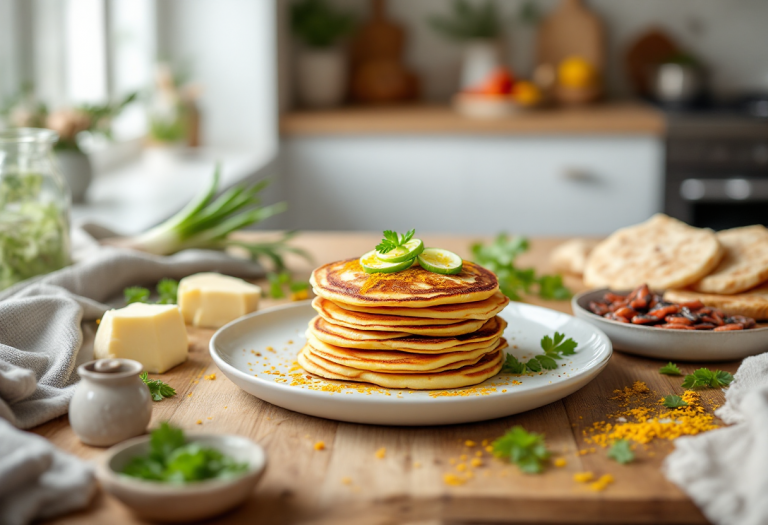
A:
[[291, 0, 353, 108]]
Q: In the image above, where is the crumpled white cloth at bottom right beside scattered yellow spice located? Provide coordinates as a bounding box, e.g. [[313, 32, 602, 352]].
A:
[[664, 353, 768, 525]]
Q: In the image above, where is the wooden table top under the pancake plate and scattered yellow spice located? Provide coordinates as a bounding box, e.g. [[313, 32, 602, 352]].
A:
[[34, 233, 739, 525]]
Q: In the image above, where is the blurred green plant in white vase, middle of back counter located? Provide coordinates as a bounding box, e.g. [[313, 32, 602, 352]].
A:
[[428, 0, 503, 90]]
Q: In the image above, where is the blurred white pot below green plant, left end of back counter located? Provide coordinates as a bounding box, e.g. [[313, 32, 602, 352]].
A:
[[296, 48, 347, 108]]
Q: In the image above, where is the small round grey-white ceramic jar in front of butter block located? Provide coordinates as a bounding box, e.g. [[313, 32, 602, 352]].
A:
[[69, 359, 152, 447]]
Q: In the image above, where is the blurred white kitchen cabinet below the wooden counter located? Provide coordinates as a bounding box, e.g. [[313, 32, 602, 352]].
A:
[[281, 135, 662, 235]]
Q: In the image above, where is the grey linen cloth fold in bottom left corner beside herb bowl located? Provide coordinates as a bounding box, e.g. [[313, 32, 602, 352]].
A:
[[0, 419, 96, 525]]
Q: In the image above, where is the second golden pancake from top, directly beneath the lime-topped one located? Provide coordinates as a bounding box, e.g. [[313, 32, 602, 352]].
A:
[[334, 292, 509, 324]]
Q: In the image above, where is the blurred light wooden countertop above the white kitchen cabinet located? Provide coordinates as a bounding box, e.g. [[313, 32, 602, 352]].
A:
[[280, 102, 665, 137]]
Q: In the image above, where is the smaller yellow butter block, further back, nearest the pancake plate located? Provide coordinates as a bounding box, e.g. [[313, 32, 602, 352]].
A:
[[179, 273, 261, 328]]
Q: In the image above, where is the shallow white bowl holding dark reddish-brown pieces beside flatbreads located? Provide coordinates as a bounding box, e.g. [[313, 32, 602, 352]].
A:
[[571, 288, 768, 361]]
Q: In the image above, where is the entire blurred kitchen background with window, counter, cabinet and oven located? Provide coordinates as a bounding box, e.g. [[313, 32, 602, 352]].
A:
[[0, 0, 768, 236]]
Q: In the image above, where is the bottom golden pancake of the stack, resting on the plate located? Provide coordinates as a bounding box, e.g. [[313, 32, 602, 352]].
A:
[[298, 346, 502, 390]]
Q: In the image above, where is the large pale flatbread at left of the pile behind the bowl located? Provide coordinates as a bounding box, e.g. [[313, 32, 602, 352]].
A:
[[584, 214, 723, 291]]
